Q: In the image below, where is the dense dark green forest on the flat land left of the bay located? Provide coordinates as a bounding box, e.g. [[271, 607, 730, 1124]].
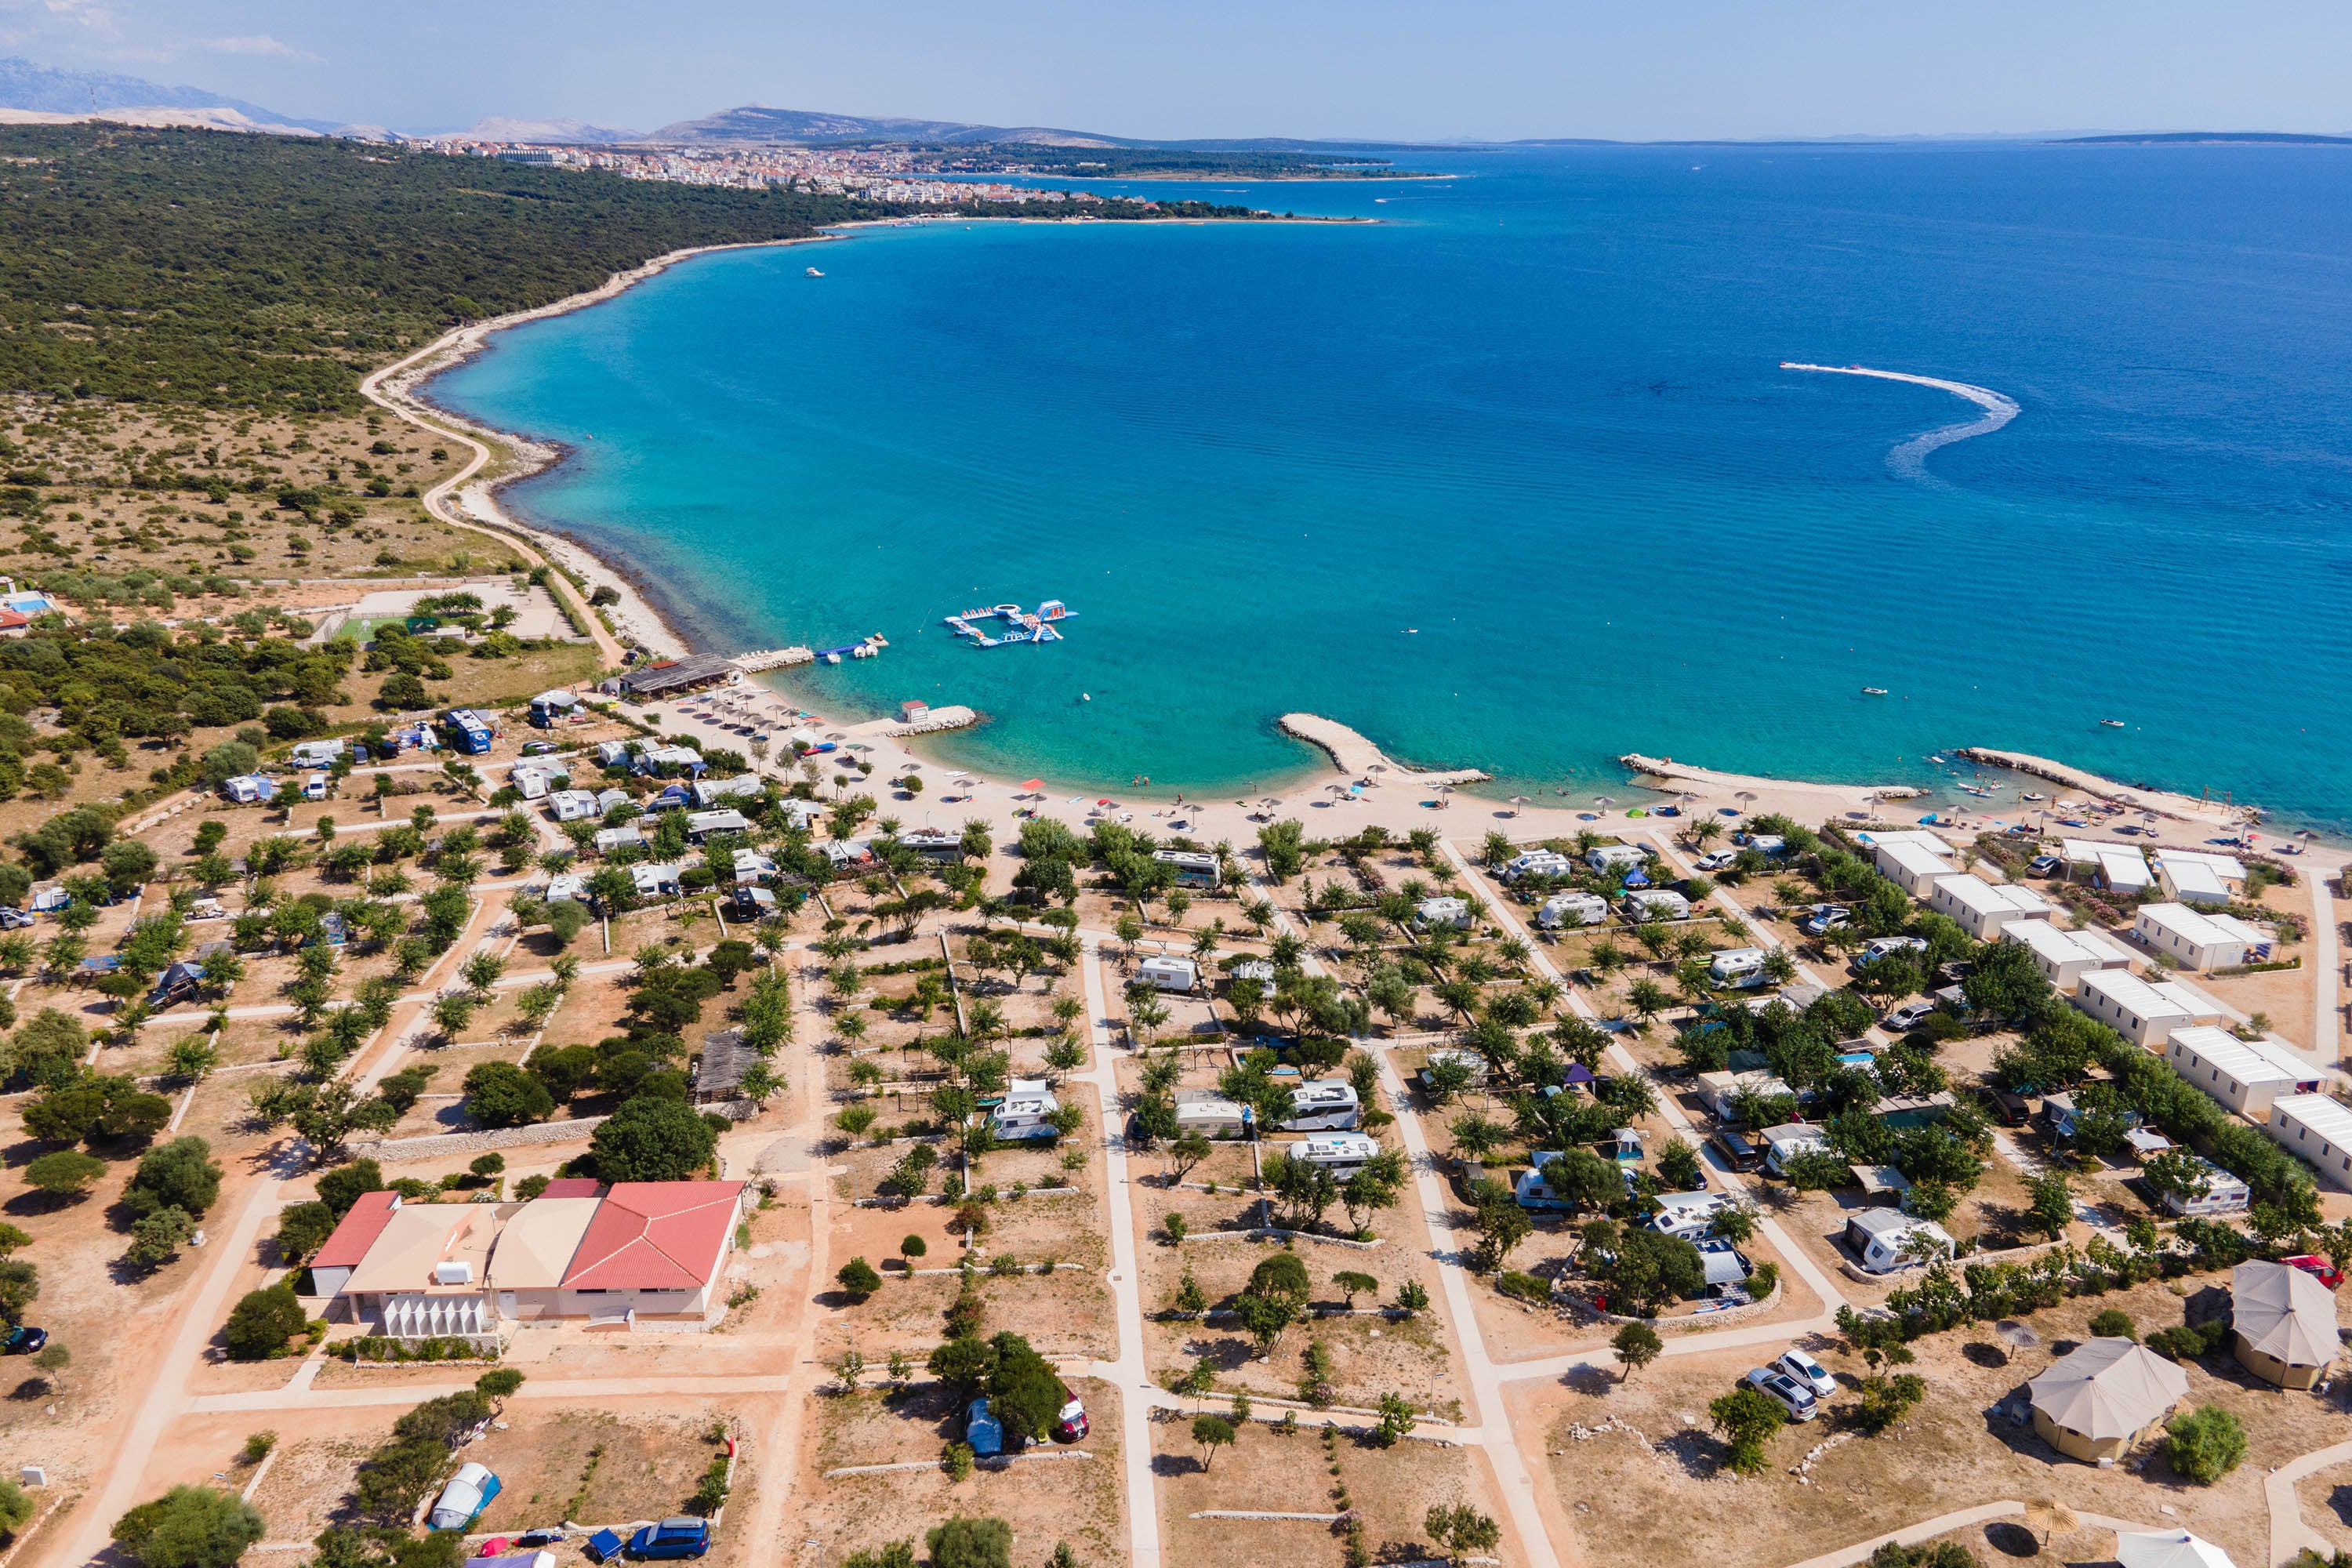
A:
[[0, 125, 1258, 412]]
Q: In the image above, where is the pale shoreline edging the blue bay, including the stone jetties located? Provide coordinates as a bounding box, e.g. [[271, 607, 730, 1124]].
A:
[[360, 220, 2343, 837]]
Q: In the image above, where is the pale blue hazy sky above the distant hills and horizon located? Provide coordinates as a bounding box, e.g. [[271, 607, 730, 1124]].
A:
[[0, 0, 2352, 141]]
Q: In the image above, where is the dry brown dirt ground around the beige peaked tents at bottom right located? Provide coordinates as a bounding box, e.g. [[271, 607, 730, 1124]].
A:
[[1545, 1281, 2343, 1568]]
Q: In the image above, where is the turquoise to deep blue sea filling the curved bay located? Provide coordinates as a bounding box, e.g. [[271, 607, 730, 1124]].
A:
[[435, 146, 2352, 825]]
